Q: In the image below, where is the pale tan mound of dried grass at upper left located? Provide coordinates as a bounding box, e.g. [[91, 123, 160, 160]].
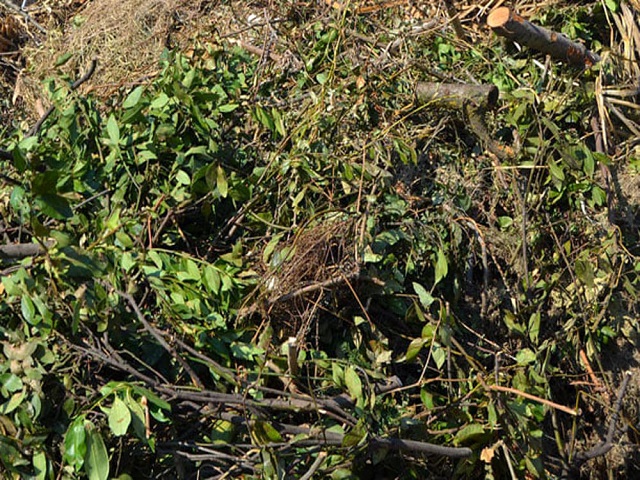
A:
[[20, 0, 202, 115]]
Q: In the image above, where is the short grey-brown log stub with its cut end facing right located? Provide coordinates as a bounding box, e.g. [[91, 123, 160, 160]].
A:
[[416, 82, 499, 110]]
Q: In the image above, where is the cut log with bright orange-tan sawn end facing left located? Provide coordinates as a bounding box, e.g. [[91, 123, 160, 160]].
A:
[[487, 7, 600, 68]]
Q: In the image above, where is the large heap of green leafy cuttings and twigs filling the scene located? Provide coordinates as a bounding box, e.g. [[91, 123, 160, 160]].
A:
[[0, 1, 640, 479]]
